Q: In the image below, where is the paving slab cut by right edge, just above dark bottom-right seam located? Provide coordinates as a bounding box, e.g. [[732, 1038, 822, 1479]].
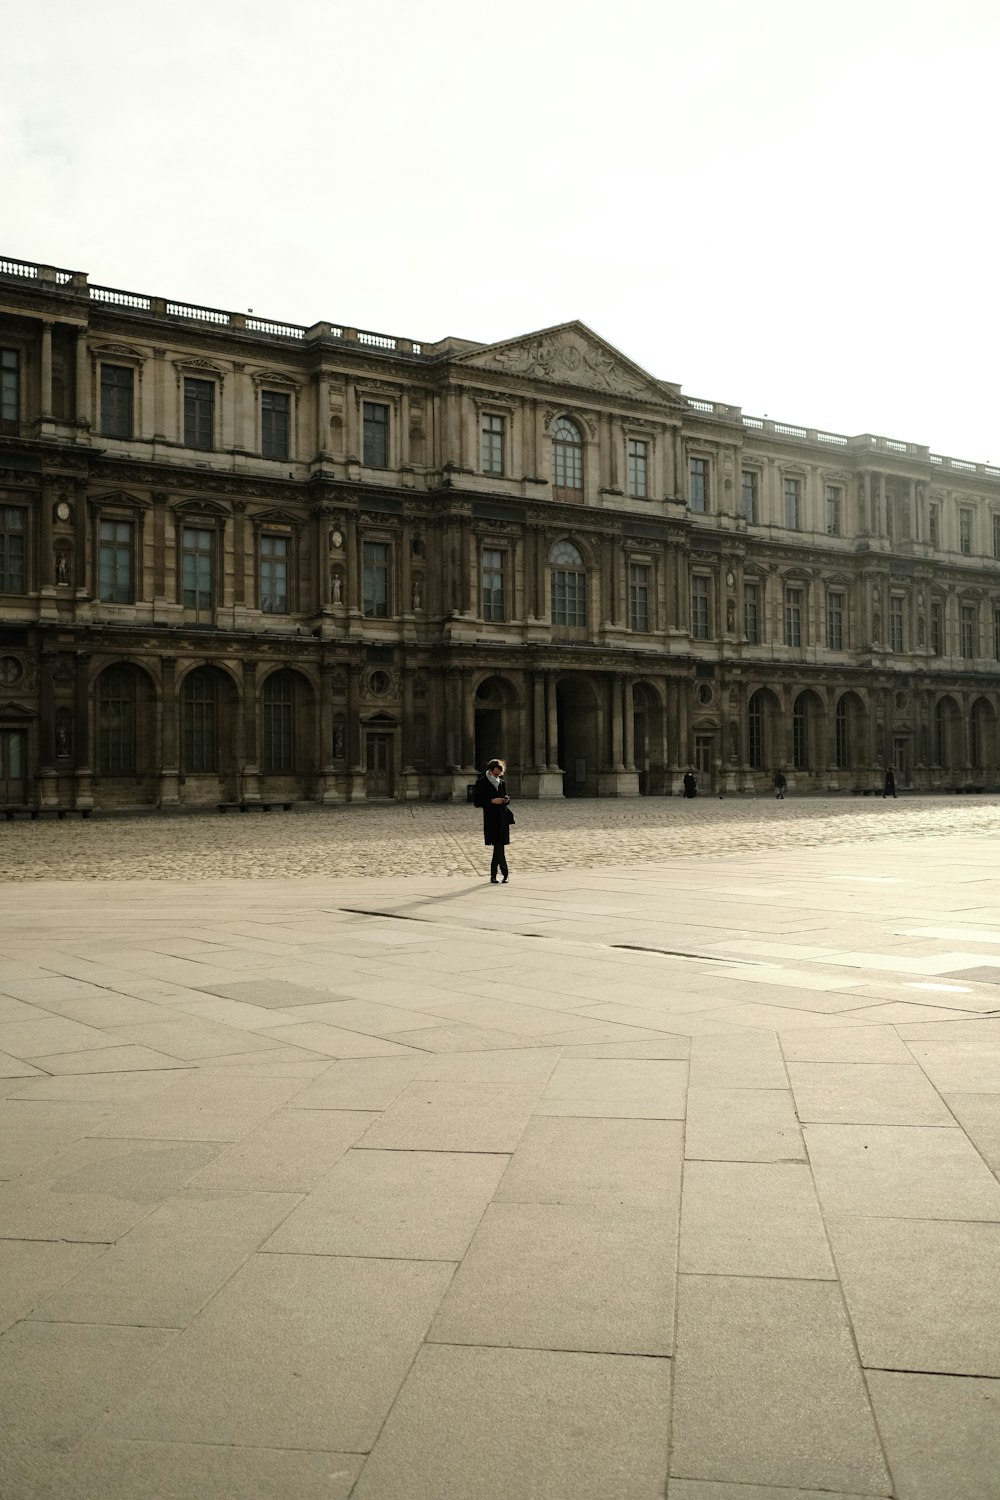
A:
[[828, 1218, 1000, 1377]]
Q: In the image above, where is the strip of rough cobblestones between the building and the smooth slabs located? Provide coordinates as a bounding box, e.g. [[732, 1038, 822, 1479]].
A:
[[0, 797, 1000, 881]]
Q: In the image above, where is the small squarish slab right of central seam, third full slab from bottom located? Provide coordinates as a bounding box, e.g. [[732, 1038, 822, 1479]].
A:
[[685, 1089, 805, 1161]]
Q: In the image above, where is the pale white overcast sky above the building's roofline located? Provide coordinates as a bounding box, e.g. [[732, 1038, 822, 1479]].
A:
[[0, 0, 1000, 462]]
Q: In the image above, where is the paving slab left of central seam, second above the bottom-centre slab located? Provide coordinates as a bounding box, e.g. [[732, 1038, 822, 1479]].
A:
[[496, 1118, 684, 1214]]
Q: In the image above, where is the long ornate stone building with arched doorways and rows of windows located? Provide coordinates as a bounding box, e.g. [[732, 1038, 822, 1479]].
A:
[[0, 260, 1000, 809]]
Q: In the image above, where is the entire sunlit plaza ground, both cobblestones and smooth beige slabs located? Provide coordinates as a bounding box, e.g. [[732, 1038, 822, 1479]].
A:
[[0, 798, 1000, 1500]]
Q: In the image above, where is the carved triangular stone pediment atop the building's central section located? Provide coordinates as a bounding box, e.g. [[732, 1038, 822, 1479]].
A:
[[456, 323, 682, 405]]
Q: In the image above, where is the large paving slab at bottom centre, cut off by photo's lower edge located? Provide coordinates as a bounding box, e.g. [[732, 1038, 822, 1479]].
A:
[[352, 1346, 670, 1500]]
